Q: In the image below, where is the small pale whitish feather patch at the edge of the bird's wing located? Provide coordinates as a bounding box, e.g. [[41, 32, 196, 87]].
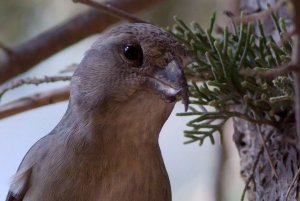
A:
[[6, 167, 32, 201]]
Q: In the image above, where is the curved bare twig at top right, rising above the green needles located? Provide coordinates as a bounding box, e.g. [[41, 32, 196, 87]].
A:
[[233, 0, 286, 24]]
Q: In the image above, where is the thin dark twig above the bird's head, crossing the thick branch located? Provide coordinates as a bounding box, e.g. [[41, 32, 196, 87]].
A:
[[73, 0, 149, 23]]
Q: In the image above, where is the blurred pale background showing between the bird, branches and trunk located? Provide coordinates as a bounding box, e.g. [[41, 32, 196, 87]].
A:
[[0, 0, 244, 201]]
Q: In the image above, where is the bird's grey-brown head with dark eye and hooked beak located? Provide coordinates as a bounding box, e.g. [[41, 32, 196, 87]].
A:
[[71, 23, 188, 113]]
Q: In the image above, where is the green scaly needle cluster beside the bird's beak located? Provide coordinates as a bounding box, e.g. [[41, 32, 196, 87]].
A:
[[169, 14, 294, 144]]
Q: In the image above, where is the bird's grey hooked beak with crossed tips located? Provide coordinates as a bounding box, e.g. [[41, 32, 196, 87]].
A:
[[147, 60, 189, 111]]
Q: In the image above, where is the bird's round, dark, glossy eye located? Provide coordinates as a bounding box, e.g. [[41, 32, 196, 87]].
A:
[[123, 45, 143, 67]]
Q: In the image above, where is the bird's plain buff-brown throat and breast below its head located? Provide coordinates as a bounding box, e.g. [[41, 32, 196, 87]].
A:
[[47, 91, 174, 201]]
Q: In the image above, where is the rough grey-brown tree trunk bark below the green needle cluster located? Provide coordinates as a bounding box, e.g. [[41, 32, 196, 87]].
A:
[[233, 118, 299, 201]]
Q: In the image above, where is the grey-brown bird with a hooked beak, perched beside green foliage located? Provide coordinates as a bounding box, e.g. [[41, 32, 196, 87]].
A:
[[6, 23, 189, 201]]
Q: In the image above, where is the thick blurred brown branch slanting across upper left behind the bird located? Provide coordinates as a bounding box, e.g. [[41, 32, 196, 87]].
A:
[[0, 0, 162, 84]]
